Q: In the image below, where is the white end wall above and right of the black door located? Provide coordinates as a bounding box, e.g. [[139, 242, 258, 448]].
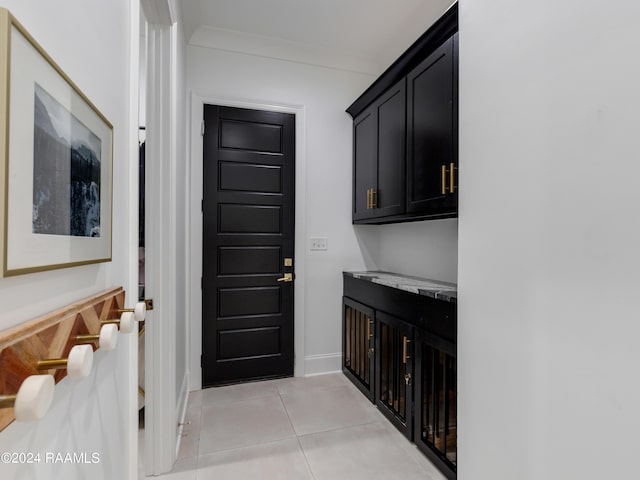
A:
[[187, 46, 375, 373]]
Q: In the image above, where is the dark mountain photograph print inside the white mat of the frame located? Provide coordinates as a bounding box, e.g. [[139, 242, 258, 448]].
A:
[[32, 83, 102, 237]]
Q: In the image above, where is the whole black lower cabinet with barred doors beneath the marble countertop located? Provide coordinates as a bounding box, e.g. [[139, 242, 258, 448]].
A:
[[342, 274, 458, 479]]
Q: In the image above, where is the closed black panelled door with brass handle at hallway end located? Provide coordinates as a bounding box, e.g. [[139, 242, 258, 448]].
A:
[[202, 105, 295, 386]]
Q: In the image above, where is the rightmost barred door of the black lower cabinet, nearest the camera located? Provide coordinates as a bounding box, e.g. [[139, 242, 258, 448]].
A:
[[414, 330, 458, 479]]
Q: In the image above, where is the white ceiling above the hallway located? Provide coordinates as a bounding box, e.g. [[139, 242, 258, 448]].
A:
[[181, 0, 453, 74]]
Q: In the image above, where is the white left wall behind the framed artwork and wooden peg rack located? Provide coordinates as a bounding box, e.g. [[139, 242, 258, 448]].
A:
[[0, 0, 137, 480]]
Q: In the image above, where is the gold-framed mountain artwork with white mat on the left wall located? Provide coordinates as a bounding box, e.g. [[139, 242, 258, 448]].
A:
[[0, 9, 113, 276]]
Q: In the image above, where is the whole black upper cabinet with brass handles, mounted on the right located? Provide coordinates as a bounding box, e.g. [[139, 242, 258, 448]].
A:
[[347, 4, 458, 223]]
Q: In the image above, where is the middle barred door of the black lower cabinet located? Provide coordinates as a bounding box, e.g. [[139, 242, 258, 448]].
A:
[[376, 312, 413, 440]]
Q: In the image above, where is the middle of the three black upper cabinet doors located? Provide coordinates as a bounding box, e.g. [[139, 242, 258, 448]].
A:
[[373, 78, 406, 217]]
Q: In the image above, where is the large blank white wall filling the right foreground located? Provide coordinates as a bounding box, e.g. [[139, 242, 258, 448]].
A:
[[458, 0, 640, 480]]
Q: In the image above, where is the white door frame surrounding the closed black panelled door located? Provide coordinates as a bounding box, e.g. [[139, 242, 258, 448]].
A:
[[187, 92, 306, 391]]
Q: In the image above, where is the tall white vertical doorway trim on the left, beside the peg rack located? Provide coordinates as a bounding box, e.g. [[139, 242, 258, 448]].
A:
[[145, 19, 177, 475]]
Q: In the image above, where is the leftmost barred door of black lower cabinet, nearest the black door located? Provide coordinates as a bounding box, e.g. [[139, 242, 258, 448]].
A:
[[342, 298, 375, 402]]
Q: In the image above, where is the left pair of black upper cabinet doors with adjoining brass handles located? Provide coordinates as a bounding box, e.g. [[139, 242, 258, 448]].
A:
[[353, 79, 406, 221]]
